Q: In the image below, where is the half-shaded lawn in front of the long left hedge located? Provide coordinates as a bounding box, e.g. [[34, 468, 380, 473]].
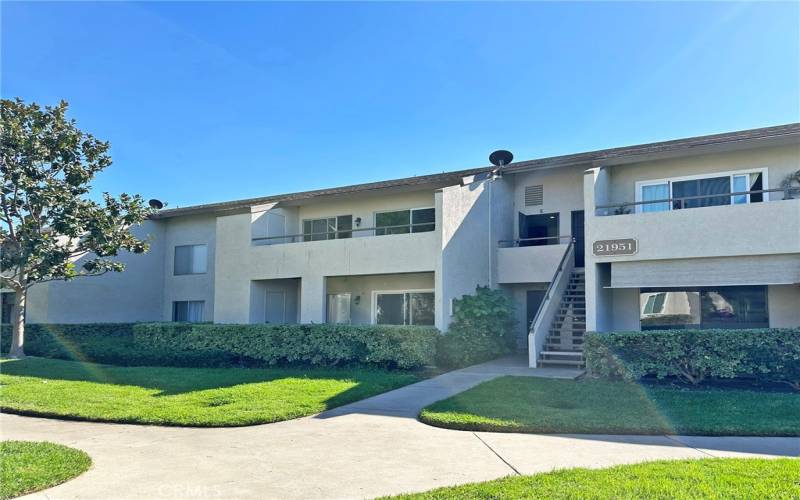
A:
[[0, 358, 417, 427]]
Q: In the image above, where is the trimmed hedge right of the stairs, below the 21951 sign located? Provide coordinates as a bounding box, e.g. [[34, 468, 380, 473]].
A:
[[584, 328, 800, 390]]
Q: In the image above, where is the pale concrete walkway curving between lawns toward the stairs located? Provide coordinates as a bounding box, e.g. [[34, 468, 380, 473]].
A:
[[0, 360, 800, 499]]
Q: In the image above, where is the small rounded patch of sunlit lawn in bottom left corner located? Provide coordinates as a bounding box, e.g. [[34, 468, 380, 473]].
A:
[[0, 441, 92, 498]]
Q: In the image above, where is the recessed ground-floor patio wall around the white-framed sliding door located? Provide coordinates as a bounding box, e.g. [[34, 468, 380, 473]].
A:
[[326, 272, 435, 325]]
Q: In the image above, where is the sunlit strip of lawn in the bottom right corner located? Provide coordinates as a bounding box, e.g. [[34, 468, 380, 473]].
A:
[[390, 458, 800, 500]]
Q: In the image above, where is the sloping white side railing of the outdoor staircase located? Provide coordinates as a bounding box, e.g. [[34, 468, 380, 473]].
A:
[[528, 238, 575, 368]]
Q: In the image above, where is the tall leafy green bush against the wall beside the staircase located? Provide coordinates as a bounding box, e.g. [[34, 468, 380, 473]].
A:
[[437, 287, 516, 368]]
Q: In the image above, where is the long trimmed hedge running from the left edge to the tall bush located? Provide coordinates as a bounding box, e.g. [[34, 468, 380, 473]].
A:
[[0, 323, 439, 369]]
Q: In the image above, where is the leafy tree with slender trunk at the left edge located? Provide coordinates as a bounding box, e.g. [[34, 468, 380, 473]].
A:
[[0, 98, 152, 357]]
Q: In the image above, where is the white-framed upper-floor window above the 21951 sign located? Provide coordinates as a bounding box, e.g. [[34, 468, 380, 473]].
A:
[[636, 169, 766, 212]]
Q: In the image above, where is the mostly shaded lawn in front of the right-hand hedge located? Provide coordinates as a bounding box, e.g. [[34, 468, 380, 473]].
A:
[[420, 377, 800, 436]]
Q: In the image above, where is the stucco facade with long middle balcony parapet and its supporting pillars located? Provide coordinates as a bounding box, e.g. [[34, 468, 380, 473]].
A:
[[214, 189, 441, 323]]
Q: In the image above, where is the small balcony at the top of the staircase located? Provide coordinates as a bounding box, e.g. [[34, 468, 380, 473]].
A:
[[497, 236, 572, 284]]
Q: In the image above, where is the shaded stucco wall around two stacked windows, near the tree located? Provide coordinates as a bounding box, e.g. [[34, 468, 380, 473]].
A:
[[161, 215, 217, 321]]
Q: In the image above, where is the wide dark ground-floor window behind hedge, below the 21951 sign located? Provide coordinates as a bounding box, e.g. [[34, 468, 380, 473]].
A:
[[640, 286, 769, 330]]
